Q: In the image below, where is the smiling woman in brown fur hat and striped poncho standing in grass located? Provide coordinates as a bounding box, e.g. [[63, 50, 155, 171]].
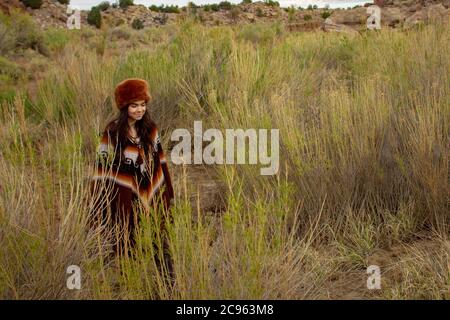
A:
[[93, 78, 173, 262]]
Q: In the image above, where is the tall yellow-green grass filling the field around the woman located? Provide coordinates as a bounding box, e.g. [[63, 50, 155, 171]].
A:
[[0, 22, 450, 299]]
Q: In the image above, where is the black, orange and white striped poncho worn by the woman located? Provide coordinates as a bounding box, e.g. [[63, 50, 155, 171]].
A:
[[93, 120, 174, 215]]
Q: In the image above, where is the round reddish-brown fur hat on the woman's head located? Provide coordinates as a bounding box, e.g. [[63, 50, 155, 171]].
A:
[[114, 78, 151, 109]]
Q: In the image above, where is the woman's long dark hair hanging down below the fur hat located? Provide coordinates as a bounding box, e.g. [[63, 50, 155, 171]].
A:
[[106, 105, 156, 159]]
